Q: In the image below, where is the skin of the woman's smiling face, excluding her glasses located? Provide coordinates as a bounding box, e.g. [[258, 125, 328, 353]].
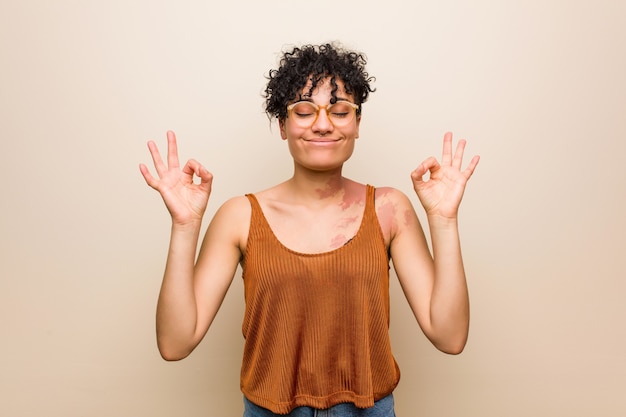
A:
[[279, 78, 361, 171]]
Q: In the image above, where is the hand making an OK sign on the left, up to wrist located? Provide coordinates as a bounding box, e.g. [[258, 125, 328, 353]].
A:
[[139, 131, 213, 225]]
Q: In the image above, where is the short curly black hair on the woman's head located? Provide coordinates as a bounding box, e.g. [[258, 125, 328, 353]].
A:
[[264, 43, 375, 120]]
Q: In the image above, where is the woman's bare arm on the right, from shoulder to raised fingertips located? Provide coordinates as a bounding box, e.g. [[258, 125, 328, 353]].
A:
[[391, 134, 478, 354]]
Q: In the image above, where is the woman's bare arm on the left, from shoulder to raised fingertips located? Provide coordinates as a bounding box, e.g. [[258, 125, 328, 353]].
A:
[[140, 132, 245, 360]]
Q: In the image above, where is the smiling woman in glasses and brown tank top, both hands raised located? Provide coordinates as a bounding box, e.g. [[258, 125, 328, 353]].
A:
[[140, 45, 478, 417]]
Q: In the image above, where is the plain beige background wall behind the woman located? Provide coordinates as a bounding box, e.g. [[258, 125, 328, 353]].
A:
[[0, 0, 626, 417]]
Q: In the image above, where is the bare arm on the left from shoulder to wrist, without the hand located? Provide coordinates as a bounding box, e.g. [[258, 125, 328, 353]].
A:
[[156, 199, 247, 360]]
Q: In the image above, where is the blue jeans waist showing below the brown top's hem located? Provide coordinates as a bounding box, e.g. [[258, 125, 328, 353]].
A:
[[243, 394, 396, 417]]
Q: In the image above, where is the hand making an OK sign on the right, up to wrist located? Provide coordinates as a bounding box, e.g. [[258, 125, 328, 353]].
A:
[[411, 132, 480, 219]]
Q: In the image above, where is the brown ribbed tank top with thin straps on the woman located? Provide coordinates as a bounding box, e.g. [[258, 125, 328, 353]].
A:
[[241, 185, 400, 414]]
